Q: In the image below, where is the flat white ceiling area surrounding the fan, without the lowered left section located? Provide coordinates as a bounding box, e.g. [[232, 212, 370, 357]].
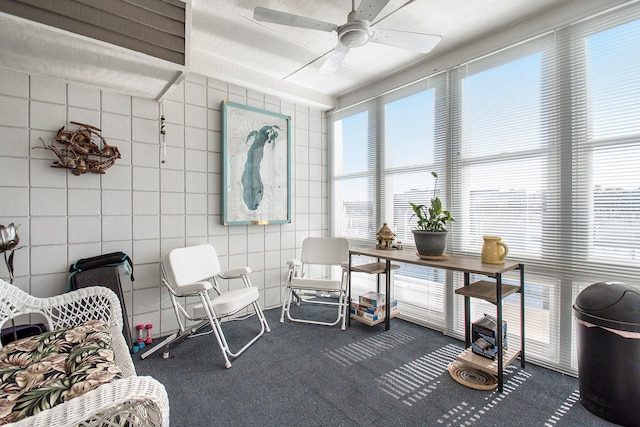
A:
[[191, 0, 566, 107]]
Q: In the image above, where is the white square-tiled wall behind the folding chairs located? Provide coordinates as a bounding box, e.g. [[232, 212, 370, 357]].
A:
[[0, 70, 328, 337]]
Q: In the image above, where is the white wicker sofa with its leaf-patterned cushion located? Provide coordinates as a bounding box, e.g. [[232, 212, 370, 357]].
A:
[[0, 279, 169, 427]]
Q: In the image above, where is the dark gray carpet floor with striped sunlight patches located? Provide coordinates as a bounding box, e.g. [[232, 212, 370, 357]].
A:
[[134, 309, 614, 427]]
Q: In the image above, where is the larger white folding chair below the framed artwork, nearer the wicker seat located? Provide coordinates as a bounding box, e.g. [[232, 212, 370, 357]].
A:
[[142, 244, 271, 368]]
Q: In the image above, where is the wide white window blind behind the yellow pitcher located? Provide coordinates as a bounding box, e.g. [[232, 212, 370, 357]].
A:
[[451, 34, 561, 365]]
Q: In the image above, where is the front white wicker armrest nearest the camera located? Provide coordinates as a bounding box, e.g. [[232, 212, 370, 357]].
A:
[[7, 376, 169, 427]]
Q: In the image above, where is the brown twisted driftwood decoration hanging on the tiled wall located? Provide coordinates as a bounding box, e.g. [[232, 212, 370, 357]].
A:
[[38, 122, 120, 175]]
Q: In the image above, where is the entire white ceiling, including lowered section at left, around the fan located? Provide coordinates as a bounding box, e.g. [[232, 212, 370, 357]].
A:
[[0, 0, 632, 109]]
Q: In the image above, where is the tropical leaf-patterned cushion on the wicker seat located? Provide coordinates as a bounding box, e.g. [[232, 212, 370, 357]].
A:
[[0, 320, 122, 424]]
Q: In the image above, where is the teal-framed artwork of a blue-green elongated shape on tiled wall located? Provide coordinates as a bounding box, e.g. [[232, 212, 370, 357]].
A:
[[222, 100, 291, 225]]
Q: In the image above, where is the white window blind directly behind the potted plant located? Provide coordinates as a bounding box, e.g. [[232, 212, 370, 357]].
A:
[[376, 73, 450, 329]]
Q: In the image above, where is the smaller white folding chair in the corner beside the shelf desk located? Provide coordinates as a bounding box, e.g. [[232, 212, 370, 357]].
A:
[[280, 237, 349, 330]]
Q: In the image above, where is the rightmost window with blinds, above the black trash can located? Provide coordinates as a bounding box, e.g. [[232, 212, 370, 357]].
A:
[[576, 20, 640, 270]]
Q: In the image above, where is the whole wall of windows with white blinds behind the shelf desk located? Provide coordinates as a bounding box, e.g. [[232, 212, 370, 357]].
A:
[[330, 5, 640, 373]]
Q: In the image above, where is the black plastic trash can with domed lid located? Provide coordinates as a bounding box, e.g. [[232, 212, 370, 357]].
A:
[[573, 282, 640, 426]]
